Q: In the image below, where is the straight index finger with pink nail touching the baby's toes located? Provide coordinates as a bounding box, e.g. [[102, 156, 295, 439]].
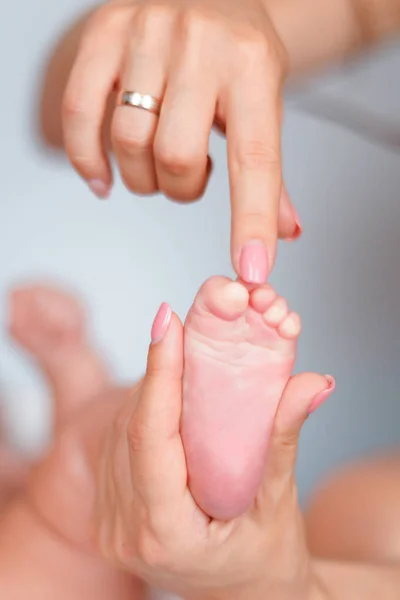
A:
[[226, 44, 282, 284]]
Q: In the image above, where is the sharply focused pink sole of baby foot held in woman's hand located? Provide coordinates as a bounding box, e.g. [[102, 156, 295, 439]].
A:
[[181, 277, 301, 520]]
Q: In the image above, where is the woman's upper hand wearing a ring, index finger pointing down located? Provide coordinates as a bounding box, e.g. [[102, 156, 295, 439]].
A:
[[63, 0, 301, 283]]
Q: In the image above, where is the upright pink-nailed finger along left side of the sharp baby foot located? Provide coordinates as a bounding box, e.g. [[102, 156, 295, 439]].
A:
[[128, 304, 187, 516]]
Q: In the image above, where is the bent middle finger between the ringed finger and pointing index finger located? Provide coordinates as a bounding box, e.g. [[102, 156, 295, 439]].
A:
[[154, 27, 217, 201]]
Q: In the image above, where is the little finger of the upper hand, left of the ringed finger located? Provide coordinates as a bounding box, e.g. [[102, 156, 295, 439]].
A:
[[62, 5, 130, 198]]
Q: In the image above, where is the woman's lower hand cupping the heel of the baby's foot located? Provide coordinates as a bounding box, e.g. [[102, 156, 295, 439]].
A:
[[30, 308, 332, 600]]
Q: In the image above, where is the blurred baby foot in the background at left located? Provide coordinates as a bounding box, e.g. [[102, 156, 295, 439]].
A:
[[9, 285, 108, 418]]
